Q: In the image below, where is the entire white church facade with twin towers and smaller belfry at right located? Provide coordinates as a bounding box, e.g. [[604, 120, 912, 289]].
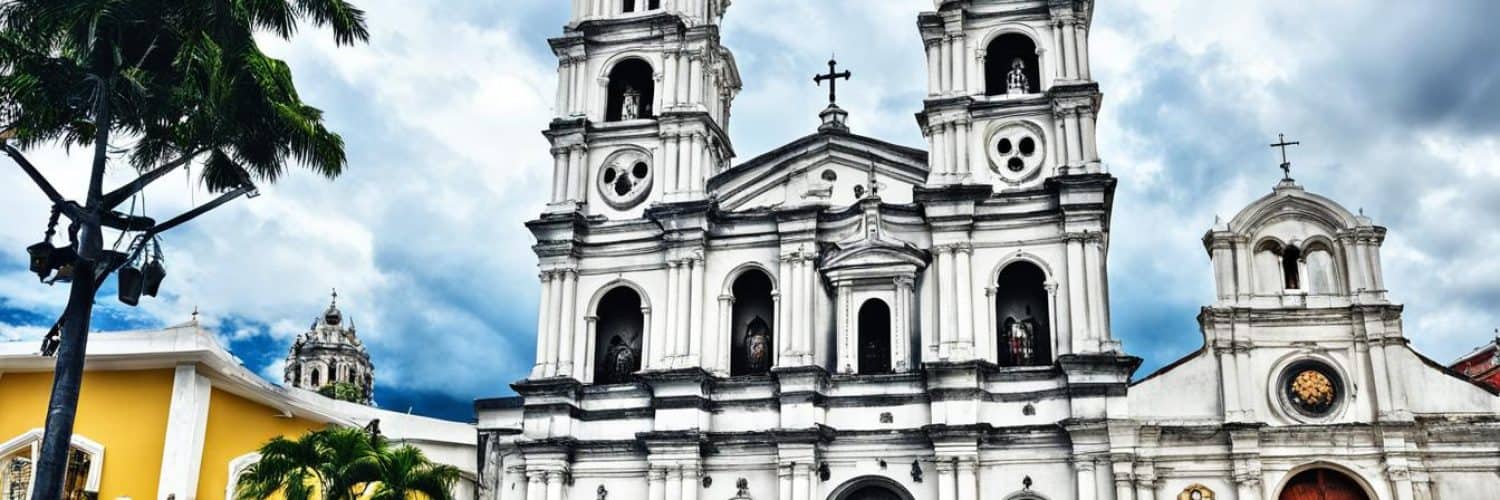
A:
[[476, 0, 1500, 500]]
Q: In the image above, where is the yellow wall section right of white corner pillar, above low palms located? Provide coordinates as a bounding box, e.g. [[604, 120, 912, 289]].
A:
[[198, 387, 324, 500]]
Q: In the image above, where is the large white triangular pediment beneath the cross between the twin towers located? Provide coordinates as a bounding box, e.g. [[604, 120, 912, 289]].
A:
[[708, 132, 927, 212]]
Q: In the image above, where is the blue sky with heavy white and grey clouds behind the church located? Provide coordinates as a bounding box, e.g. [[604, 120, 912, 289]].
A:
[[0, 0, 1500, 419]]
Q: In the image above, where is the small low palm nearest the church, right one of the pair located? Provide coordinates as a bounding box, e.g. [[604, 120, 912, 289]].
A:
[[368, 444, 459, 500]]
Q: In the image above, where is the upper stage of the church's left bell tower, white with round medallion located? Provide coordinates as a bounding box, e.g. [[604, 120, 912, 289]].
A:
[[545, 0, 740, 219]]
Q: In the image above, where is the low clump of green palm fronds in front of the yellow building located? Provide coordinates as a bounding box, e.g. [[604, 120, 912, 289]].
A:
[[237, 428, 459, 500]]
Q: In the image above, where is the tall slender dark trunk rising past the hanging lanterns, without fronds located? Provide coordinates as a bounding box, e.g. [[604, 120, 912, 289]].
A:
[[32, 67, 114, 500]]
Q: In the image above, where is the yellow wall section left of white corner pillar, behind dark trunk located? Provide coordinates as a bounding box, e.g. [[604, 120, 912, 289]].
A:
[[0, 369, 174, 498]]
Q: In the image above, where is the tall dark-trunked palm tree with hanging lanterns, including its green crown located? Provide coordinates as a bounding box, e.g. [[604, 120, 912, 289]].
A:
[[0, 0, 369, 500]]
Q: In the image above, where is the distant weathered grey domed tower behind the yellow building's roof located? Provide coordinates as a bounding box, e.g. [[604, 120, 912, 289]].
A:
[[282, 291, 375, 404]]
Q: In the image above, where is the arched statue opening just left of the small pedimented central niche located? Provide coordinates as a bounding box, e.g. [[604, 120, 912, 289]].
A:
[[729, 270, 776, 375]]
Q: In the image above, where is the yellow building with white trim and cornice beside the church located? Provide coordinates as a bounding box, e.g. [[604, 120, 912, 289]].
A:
[[0, 321, 476, 500]]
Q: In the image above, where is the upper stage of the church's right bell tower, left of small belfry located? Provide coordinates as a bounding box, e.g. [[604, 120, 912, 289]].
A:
[[918, 0, 1103, 191]]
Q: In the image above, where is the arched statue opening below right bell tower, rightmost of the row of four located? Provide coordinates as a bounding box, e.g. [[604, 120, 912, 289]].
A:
[[995, 261, 1052, 366]]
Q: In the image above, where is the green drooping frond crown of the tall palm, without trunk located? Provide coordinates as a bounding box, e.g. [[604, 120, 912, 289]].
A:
[[0, 0, 369, 191]]
